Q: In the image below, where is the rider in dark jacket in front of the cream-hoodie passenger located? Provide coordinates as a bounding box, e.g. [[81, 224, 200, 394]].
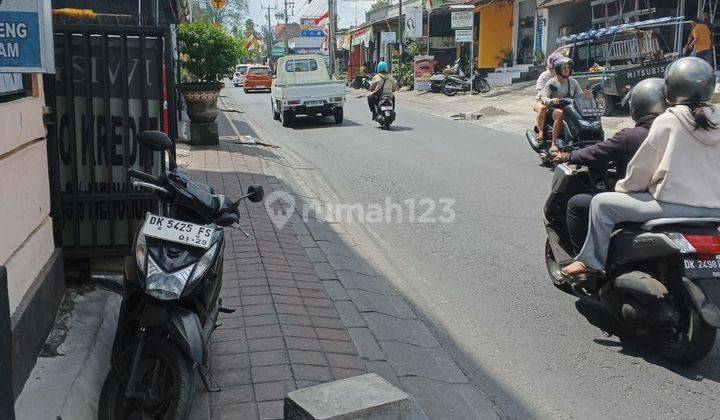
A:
[[553, 78, 667, 253]]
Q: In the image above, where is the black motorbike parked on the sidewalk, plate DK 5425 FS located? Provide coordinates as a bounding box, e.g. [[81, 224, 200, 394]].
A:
[[98, 131, 263, 419]]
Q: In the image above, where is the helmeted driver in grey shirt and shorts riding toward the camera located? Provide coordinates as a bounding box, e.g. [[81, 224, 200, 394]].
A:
[[540, 57, 583, 150]]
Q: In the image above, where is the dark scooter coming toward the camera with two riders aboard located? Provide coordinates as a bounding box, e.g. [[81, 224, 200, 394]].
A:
[[525, 96, 605, 166]]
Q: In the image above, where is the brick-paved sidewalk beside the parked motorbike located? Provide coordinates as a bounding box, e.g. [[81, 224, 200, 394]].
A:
[[180, 91, 498, 419]]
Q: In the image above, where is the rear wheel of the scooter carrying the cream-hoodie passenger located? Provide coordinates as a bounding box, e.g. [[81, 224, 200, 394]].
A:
[[650, 308, 717, 365]]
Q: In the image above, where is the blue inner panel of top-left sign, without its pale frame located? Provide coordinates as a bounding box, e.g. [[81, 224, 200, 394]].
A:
[[0, 12, 42, 67]]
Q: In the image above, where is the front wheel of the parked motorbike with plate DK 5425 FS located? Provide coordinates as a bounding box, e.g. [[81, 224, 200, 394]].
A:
[[98, 338, 195, 420]]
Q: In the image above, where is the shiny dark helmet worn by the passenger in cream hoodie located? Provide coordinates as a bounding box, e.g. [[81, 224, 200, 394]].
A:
[[665, 57, 716, 106]]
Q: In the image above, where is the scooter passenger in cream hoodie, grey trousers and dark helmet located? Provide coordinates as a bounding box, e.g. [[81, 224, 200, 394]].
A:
[[562, 57, 720, 276]]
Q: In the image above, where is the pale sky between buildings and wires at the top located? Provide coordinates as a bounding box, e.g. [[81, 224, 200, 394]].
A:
[[248, 0, 375, 28]]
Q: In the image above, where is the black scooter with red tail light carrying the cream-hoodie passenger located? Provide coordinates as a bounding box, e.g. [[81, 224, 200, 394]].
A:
[[544, 164, 720, 365]]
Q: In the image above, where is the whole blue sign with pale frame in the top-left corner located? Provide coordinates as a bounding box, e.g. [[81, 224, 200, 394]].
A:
[[0, 0, 55, 73]]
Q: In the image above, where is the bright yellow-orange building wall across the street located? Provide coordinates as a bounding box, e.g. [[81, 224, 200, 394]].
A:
[[475, 3, 513, 69]]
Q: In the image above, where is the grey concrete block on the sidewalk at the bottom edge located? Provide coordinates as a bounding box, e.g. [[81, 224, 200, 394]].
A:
[[284, 373, 427, 420]]
